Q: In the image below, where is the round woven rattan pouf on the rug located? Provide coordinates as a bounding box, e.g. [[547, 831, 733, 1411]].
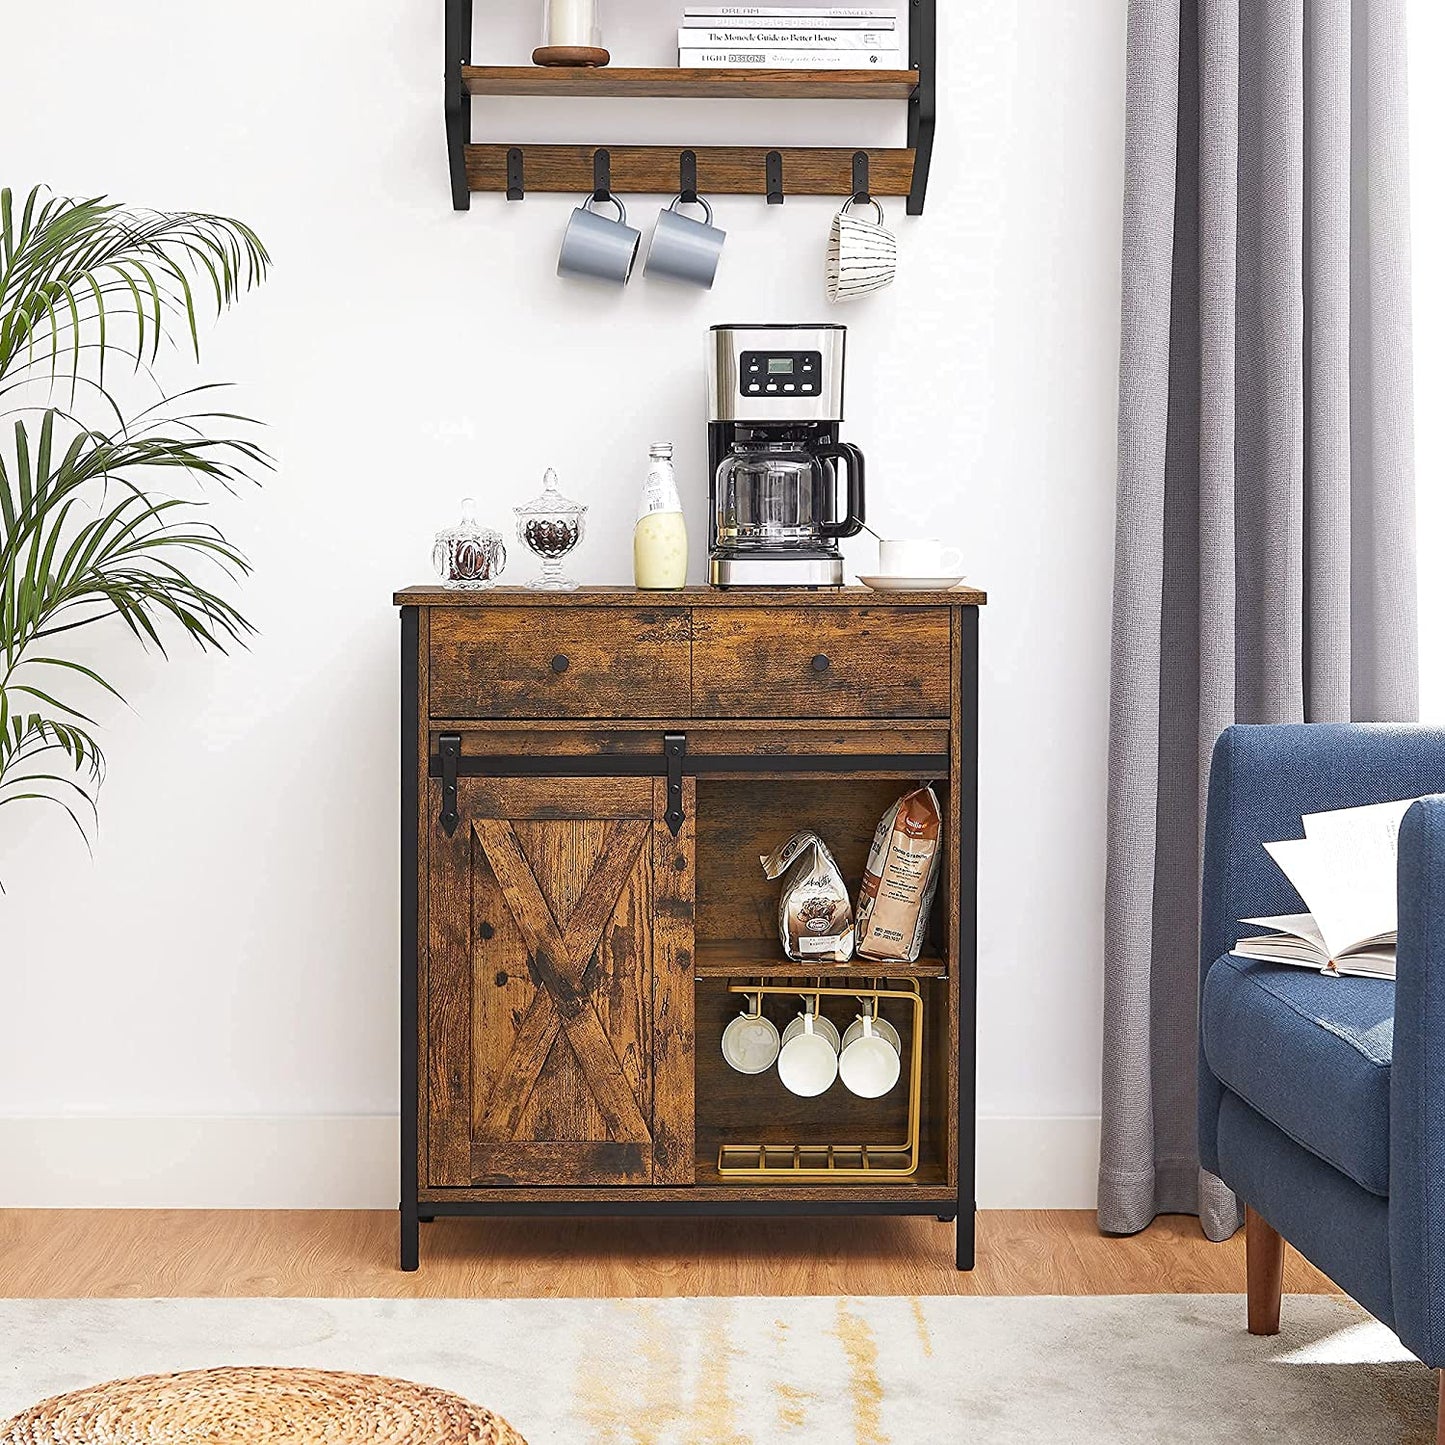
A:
[[0, 1368, 526, 1445]]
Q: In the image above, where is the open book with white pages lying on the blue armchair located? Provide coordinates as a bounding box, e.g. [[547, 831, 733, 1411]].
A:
[[1234, 798, 1415, 978]]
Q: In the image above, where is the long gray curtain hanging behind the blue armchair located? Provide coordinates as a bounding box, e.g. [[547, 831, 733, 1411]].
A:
[[1100, 0, 1418, 1238]]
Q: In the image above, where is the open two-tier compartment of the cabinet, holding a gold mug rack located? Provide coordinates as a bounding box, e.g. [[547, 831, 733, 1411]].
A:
[[694, 776, 957, 1198]]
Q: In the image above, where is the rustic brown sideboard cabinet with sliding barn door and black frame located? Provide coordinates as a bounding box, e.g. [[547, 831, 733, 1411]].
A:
[[396, 588, 985, 1270]]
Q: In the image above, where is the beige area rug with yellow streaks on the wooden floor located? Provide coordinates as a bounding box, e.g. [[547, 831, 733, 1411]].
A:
[[0, 1295, 1436, 1445]]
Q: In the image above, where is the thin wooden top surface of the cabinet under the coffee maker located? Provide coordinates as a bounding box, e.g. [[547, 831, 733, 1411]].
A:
[[392, 587, 988, 607]]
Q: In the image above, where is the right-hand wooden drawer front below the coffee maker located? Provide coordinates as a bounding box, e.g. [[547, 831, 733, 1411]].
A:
[[692, 607, 951, 718]]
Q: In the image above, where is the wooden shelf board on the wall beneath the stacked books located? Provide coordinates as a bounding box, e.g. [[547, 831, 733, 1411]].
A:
[[461, 65, 918, 100]]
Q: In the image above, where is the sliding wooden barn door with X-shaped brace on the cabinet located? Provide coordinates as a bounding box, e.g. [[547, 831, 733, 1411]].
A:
[[426, 777, 694, 1188]]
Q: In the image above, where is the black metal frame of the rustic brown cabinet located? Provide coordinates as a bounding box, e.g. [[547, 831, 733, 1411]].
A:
[[400, 607, 978, 1270]]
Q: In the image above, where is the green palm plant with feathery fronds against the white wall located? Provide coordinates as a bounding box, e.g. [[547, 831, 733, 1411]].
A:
[[0, 188, 270, 841]]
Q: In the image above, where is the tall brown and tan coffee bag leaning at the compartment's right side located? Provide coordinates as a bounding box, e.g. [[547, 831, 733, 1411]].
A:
[[858, 783, 944, 964]]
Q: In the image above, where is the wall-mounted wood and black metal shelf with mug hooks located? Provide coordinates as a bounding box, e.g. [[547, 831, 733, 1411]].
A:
[[445, 0, 938, 215]]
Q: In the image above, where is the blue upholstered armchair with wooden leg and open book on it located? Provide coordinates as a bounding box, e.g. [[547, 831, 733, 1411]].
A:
[[1199, 724, 1445, 1445]]
